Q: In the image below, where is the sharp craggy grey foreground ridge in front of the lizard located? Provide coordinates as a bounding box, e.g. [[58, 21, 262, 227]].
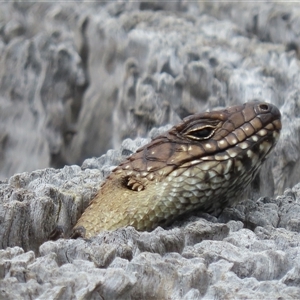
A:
[[0, 198, 300, 299]]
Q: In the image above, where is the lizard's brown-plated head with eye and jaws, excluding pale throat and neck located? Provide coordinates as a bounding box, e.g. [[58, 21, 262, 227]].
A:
[[120, 101, 281, 178]]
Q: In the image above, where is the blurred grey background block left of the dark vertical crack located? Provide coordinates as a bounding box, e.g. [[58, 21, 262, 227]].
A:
[[0, 3, 86, 178]]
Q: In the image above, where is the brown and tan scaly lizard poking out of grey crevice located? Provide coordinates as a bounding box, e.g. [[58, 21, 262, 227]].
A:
[[73, 101, 281, 238]]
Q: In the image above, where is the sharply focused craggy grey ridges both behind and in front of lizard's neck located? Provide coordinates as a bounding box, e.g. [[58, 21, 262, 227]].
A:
[[0, 145, 300, 299]]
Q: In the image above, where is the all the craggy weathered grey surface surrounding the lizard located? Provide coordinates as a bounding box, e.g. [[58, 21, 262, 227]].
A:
[[0, 1, 300, 299]]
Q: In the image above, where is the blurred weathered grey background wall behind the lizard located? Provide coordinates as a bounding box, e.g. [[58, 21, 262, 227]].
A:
[[0, 1, 300, 198]]
